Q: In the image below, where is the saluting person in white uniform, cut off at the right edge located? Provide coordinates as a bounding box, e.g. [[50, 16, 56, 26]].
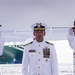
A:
[[67, 22, 75, 75]]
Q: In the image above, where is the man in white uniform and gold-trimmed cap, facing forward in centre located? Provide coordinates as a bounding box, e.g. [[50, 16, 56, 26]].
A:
[[22, 23, 58, 75]]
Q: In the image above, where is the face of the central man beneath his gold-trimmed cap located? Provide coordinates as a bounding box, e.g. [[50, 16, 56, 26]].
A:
[[33, 30, 46, 42]]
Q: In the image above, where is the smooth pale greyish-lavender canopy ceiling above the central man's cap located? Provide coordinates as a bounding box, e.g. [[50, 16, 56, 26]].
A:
[[0, 0, 75, 31]]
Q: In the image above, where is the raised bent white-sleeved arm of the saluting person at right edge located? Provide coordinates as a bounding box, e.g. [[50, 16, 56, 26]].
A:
[[67, 29, 75, 50]]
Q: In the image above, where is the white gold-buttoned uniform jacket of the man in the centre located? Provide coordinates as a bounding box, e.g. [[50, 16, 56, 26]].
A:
[[22, 40, 58, 75]]
